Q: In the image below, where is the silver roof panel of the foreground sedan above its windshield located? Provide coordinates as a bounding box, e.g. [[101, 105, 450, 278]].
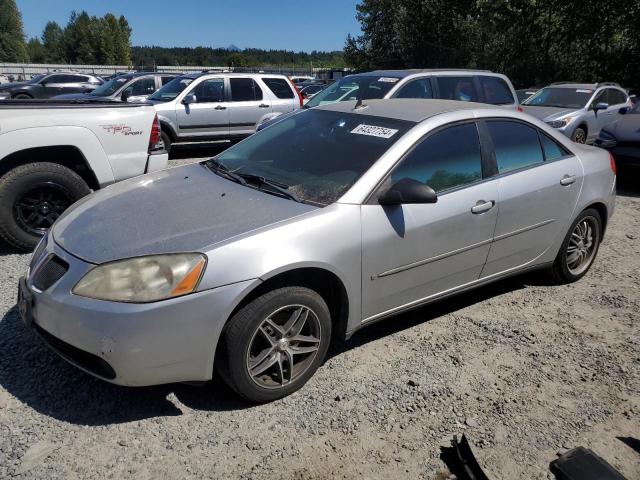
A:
[[313, 98, 495, 123]]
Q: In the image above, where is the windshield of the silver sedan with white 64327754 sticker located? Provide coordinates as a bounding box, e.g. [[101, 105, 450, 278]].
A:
[[210, 110, 414, 205]]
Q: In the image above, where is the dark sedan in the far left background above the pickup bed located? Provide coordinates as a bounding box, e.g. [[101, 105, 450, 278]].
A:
[[0, 72, 104, 100]]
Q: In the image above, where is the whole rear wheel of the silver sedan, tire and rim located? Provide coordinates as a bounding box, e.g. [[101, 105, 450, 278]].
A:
[[551, 208, 602, 283]]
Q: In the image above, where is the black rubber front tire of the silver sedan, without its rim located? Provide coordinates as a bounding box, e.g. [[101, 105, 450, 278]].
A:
[[216, 287, 331, 403]]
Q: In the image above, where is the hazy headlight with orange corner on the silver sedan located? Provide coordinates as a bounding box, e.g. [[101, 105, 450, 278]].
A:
[[73, 253, 206, 303]]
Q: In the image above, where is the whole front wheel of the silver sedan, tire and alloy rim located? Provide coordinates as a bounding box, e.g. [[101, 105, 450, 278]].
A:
[[216, 287, 331, 402]]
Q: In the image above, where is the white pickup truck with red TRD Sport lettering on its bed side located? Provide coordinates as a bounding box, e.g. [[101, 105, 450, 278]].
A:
[[0, 100, 168, 250]]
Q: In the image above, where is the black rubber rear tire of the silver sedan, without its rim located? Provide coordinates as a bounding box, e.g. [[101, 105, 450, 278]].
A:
[[549, 208, 602, 284]]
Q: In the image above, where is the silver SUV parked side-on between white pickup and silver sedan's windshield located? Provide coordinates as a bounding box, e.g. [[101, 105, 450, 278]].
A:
[[149, 73, 302, 150]]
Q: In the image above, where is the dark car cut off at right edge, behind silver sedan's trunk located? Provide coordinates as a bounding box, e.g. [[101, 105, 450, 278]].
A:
[[595, 103, 640, 167]]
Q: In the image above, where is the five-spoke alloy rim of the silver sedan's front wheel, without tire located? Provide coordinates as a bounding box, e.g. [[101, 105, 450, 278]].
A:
[[246, 305, 322, 389]]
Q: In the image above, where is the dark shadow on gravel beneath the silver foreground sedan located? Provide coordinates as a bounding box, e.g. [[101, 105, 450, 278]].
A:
[[0, 275, 535, 425]]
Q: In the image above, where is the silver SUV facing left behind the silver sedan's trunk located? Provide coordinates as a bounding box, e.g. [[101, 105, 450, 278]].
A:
[[522, 82, 633, 143]]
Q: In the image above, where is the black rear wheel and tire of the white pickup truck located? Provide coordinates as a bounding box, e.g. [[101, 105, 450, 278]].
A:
[[0, 162, 91, 251]]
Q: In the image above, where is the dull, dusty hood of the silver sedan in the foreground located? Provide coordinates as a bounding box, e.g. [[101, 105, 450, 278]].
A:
[[53, 164, 317, 263]]
